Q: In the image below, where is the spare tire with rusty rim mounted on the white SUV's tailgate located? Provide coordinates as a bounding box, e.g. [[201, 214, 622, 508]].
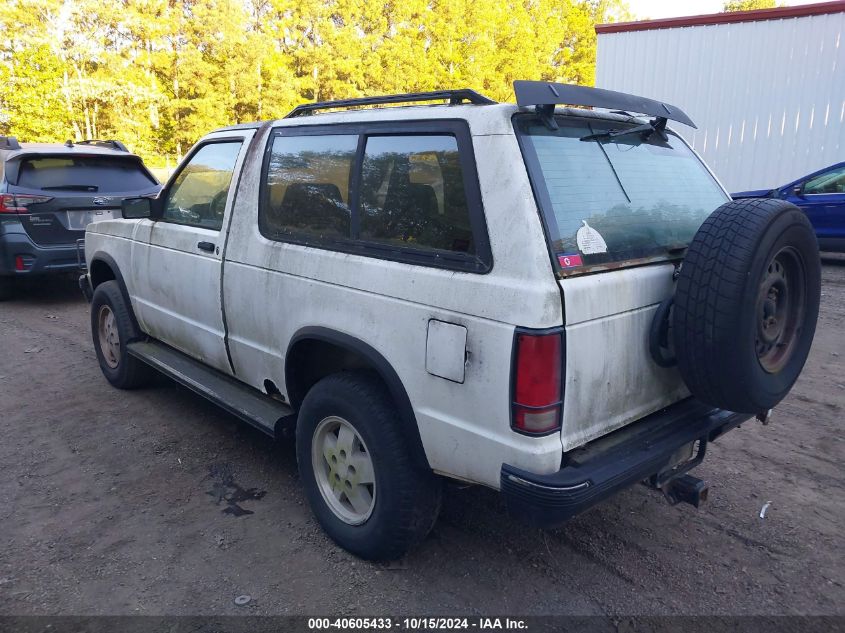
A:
[[671, 198, 821, 414]]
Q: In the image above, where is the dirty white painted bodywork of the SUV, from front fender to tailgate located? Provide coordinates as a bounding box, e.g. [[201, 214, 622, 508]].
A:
[[86, 105, 704, 488]]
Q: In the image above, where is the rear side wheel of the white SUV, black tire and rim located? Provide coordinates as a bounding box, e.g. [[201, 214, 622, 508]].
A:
[[296, 371, 442, 560]]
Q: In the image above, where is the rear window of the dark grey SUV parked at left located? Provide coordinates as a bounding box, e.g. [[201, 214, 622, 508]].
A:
[[17, 156, 158, 193]]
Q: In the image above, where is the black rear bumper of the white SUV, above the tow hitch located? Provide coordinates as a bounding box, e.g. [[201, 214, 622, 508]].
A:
[[501, 398, 751, 527]]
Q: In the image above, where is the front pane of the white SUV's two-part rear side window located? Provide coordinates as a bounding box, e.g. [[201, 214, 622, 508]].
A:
[[259, 134, 358, 239]]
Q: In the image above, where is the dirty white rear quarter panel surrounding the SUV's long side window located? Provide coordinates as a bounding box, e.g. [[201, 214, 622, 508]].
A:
[[223, 106, 563, 488]]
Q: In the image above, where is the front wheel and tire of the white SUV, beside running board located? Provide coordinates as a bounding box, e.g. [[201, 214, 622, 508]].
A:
[[91, 281, 153, 389]]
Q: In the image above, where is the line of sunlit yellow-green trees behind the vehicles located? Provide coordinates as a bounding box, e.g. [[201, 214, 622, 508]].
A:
[[0, 0, 628, 166]]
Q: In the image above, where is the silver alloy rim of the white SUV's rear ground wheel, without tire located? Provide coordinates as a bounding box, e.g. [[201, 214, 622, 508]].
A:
[[311, 416, 376, 525]]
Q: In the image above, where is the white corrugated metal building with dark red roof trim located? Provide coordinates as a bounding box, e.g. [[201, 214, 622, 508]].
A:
[[596, 0, 845, 191]]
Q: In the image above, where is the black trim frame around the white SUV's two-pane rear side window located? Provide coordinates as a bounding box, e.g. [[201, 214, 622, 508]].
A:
[[258, 119, 493, 274]]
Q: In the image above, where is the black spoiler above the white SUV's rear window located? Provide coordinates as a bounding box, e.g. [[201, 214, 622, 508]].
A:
[[513, 81, 697, 128]]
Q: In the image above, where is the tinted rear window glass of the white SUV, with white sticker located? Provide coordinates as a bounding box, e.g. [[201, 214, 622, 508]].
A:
[[516, 117, 729, 272]]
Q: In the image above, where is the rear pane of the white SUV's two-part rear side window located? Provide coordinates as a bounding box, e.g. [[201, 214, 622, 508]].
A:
[[360, 135, 474, 253]]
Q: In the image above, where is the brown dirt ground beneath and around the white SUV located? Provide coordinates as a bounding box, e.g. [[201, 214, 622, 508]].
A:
[[0, 257, 845, 615]]
